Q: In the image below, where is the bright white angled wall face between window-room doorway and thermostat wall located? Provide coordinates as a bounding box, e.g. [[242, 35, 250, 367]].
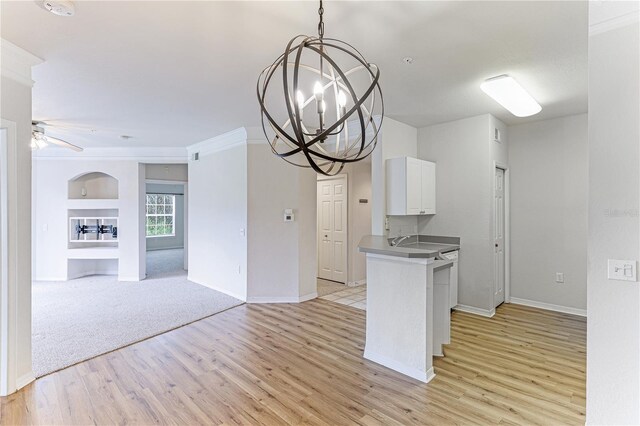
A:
[[187, 144, 247, 300]]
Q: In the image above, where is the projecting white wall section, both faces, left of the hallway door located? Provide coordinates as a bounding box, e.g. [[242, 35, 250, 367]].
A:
[[187, 128, 317, 303]]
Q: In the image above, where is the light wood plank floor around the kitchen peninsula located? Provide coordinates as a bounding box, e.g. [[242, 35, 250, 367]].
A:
[[0, 300, 586, 425]]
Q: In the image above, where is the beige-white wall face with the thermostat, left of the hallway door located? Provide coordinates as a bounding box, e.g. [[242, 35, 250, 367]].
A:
[[248, 145, 316, 302]]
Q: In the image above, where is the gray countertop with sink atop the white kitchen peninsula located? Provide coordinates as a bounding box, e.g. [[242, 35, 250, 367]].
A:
[[358, 235, 460, 258]]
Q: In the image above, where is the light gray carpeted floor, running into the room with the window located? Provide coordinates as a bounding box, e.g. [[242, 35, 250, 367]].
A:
[[32, 250, 243, 377]]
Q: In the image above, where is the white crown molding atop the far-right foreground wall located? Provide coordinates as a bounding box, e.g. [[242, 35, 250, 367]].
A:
[[589, 0, 640, 35]]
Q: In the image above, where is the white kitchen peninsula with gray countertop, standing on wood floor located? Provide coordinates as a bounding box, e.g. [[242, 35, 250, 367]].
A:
[[358, 235, 460, 383]]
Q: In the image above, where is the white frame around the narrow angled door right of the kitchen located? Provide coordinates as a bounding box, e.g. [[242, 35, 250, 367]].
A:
[[491, 161, 511, 309]]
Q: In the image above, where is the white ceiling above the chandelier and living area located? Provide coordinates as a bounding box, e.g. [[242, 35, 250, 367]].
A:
[[0, 1, 588, 147]]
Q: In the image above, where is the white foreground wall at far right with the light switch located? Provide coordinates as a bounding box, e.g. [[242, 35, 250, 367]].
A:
[[587, 2, 640, 425]]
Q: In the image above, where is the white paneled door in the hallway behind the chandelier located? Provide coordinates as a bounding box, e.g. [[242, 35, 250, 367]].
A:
[[318, 176, 347, 283]]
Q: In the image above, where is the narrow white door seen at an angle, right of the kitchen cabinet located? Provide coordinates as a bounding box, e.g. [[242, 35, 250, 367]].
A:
[[493, 168, 505, 307]]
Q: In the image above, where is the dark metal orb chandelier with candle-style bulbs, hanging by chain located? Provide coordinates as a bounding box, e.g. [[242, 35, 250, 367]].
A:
[[257, 0, 384, 176]]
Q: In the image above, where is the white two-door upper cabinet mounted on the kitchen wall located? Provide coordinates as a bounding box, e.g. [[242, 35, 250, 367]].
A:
[[386, 157, 436, 216]]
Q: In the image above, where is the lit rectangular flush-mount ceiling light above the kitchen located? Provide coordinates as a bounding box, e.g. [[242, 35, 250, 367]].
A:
[[480, 75, 542, 117]]
